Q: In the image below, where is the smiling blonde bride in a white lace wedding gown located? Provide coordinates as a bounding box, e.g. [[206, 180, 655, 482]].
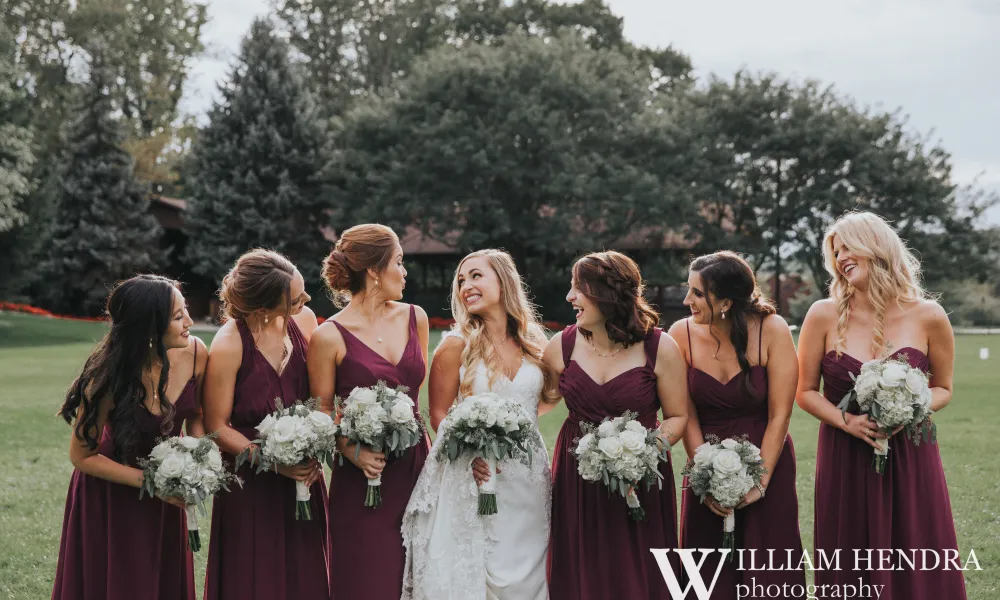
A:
[[402, 250, 557, 600]]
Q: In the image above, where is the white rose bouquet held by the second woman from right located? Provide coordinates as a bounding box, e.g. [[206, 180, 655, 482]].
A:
[[681, 434, 767, 561]]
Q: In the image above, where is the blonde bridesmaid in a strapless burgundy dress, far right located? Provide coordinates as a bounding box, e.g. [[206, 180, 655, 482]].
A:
[[796, 212, 966, 600]]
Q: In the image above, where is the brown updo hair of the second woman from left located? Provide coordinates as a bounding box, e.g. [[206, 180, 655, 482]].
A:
[[219, 248, 295, 326]]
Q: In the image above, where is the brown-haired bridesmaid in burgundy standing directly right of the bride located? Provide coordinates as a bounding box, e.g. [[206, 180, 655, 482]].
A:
[[544, 252, 688, 600]]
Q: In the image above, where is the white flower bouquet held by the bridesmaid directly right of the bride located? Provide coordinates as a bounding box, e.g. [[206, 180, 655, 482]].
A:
[[573, 411, 670, 521]]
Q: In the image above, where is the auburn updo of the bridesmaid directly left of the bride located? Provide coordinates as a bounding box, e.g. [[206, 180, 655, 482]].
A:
[[321, 223, 399, 307]]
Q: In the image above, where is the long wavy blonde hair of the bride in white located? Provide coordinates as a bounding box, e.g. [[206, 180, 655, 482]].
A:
[[451, 248, 558, 402]]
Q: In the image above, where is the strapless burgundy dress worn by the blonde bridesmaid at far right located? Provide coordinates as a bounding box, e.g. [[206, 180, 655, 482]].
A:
[[815, 348, 966, 600]]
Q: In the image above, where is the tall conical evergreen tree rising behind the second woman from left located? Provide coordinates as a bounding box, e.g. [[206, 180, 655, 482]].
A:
[[186, 20, 329, 284]]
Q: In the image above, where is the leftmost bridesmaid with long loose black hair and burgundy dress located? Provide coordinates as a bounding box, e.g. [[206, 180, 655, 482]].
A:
[[52, 275, 208, 600]]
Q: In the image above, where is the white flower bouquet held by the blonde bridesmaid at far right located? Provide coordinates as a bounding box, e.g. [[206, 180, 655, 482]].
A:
[[837, 358, 937, 475]]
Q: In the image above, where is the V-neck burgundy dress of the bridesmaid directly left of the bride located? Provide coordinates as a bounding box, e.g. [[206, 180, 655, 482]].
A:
[[330, 306, 430, 600]]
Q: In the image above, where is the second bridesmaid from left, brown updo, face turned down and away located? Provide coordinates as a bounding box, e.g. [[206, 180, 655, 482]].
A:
[[205, 250, 330, 600]]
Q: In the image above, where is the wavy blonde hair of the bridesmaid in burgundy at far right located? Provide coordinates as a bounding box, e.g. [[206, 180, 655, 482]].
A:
[[823, 212, 927, 356]]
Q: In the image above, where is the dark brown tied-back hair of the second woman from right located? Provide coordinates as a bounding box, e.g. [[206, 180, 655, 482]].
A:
[[689, 250, 775, 398]]
